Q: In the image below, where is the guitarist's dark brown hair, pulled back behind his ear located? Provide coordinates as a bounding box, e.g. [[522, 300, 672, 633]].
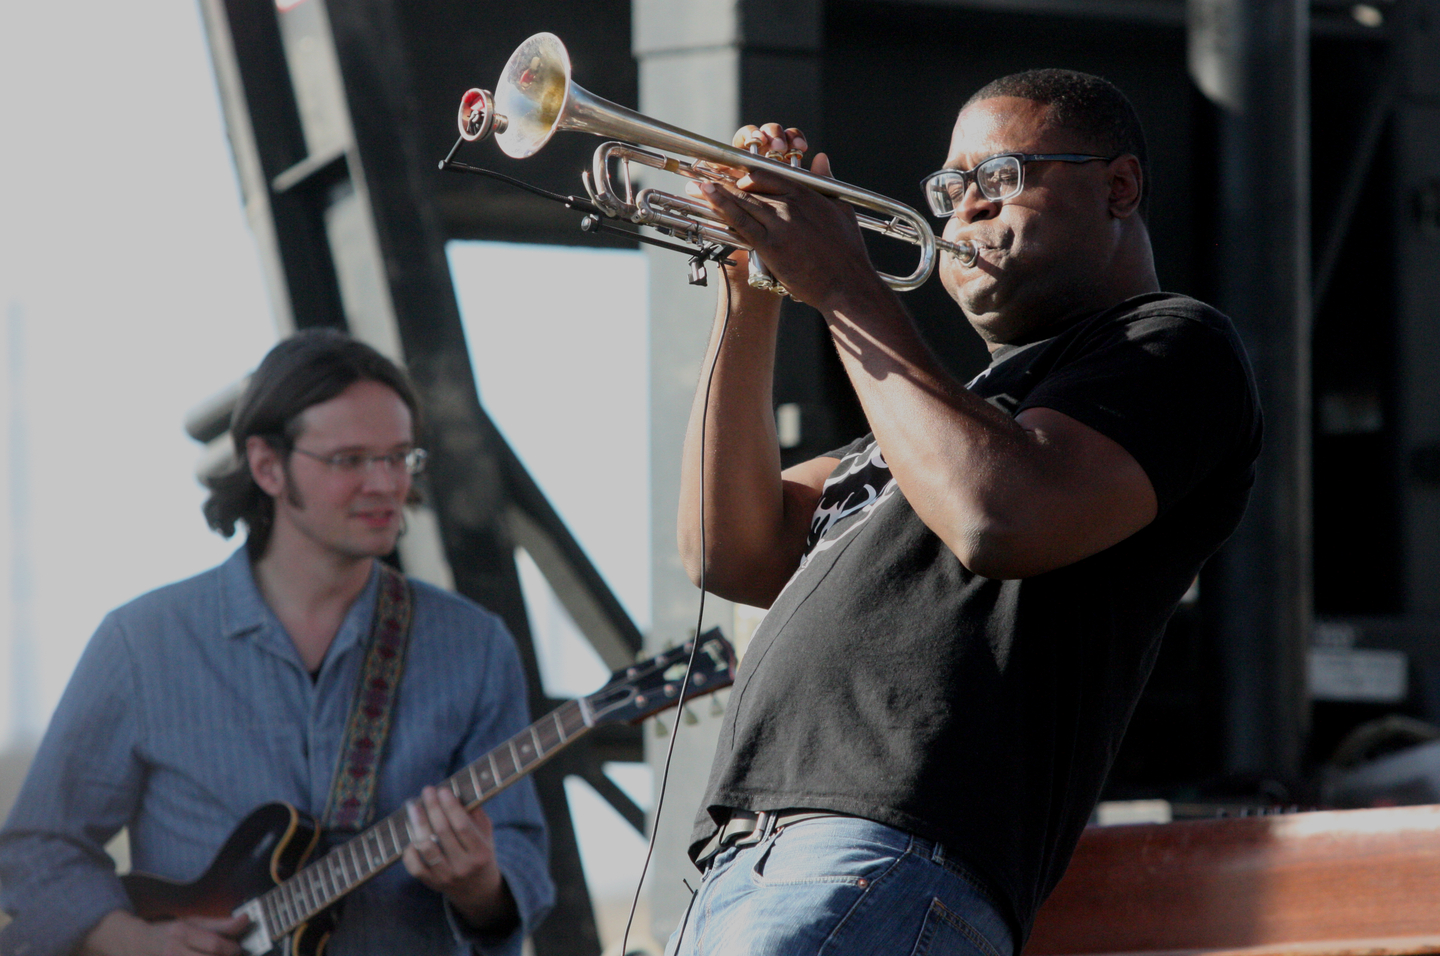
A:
[[203, 328, 420, 560]]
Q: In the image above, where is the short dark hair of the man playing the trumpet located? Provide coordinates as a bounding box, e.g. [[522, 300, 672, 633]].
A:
[[965, 69, 1151, 213]]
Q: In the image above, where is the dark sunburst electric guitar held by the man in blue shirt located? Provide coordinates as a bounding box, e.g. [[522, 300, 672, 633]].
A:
[[121, 631, 734, 956]]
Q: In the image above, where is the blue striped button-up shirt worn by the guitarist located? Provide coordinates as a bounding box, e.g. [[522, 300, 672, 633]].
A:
[[0, 549, 554, 956]]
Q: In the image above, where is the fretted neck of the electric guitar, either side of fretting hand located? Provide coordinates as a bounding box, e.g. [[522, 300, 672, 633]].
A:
[[252, 700, 595, 939]]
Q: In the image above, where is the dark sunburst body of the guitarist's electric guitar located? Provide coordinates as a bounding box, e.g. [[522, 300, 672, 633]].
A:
[[121, 803, 336, 956]]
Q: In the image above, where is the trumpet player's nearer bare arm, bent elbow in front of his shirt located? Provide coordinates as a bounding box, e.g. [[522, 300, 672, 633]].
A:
[[706, 145, 1156, 577]]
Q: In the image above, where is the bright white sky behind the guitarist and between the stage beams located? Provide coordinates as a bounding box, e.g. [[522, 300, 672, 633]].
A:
[[0, 0, 649, 909]]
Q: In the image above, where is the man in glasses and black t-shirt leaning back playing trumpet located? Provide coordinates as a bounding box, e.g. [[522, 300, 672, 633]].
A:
[[668, 71, 1260, 956]]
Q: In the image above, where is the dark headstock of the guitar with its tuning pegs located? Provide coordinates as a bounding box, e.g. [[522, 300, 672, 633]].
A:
[[585, 628, 734, 726]]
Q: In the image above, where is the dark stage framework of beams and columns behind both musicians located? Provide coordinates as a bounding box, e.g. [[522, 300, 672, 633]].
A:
[[193, 0, 1440, 956]]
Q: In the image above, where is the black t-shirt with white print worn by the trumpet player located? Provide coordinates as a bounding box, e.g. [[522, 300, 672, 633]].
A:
[[693, 294, 1260, 940]]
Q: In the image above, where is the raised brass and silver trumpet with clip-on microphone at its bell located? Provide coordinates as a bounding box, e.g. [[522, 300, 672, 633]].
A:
[[456, 33, 978, 292]]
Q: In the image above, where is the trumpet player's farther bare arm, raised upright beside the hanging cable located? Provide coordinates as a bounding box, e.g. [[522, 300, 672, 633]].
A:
[[678, 252, 835, 608]]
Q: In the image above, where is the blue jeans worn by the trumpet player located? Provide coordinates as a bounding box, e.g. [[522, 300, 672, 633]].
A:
[[665, 816, 1014, 956]]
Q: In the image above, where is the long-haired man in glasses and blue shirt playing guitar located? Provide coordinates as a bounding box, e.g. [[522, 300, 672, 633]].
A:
[[0, 330, 554, 956]]
